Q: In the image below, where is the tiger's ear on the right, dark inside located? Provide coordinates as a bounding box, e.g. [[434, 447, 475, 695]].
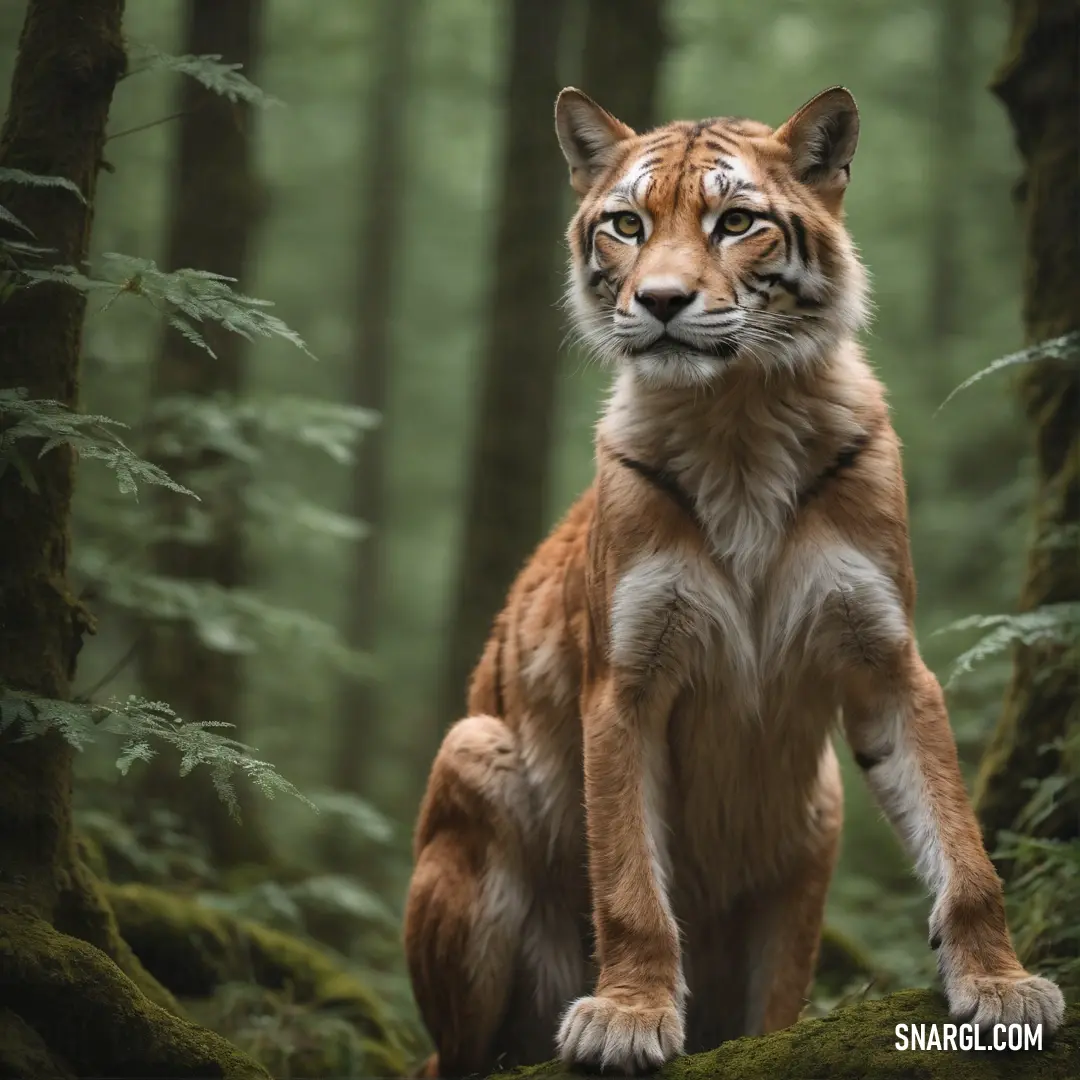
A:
[[775, 86, 859, 194]]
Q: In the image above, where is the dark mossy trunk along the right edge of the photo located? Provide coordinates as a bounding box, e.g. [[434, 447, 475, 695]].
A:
[[977, 0, 1080, 847]]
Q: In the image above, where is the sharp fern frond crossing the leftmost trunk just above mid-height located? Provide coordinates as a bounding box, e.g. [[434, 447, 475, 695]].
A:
[[0, 387, 198, 498]]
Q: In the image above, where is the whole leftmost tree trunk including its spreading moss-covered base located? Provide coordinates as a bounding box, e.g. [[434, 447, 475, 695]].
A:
[[0, 0, 259, 1077]]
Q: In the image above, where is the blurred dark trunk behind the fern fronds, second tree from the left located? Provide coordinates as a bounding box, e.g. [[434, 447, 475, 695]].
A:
[[139, 0, 272, 866]]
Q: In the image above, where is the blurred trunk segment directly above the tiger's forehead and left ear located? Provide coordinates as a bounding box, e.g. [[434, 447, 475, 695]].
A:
[[581, 0, 667, 132]]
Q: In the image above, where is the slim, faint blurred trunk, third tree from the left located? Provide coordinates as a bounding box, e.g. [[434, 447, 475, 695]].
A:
[[330, 0, 416, 816]]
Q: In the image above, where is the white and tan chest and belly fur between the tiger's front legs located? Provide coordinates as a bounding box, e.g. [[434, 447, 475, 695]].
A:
[[605, 412, 907, 902]]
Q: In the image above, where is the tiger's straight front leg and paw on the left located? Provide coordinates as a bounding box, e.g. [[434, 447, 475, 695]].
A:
[[557, 679, 686, 1075]]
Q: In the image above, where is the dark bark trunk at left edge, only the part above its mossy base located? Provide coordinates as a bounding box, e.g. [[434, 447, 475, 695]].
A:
[[0, 0, 126, 937]]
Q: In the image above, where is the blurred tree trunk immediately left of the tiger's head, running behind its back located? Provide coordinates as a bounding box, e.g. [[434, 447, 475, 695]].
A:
[[434, 0, 566, 743]]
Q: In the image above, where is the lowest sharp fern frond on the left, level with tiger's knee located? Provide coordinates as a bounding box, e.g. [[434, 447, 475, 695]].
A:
[[0, 690, 310, 818]]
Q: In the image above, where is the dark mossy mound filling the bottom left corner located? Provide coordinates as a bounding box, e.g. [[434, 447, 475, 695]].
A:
[[0, 909, 268, 1080]]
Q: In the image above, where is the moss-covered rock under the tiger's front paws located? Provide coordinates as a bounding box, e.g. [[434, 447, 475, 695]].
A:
[[492, 990, 1080, 1080]]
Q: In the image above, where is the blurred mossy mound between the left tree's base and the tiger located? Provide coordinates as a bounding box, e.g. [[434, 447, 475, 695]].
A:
[[108, 885, 406, 1077]]
